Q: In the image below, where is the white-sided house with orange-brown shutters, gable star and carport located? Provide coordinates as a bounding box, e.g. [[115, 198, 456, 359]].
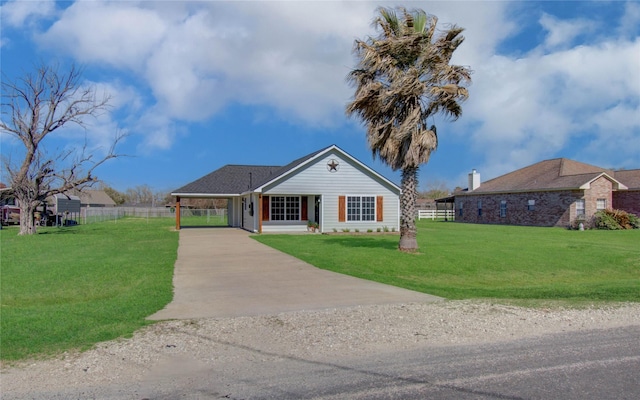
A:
[[171, 145, 400, 233]]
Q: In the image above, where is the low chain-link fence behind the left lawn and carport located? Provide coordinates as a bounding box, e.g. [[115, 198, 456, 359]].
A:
[[78, 207, 227, 224]]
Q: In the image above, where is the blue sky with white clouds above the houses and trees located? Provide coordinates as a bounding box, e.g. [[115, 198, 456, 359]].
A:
[[0, 1, 640, 191]]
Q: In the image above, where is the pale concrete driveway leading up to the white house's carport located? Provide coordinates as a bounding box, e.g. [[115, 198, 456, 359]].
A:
[[149, 228, 441, 320]]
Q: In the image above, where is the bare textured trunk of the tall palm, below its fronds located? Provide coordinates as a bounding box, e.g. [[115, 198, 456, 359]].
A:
[[398, 167, 418, 253]]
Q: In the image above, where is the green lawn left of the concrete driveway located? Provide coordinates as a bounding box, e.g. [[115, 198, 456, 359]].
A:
[[0, 218, 178, 360]]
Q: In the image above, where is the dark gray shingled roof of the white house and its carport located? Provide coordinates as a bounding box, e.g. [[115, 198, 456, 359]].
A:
[[172, 146, 332, 195]]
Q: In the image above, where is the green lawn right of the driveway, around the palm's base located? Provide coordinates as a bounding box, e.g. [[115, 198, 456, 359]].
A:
[[254, 221, 640, 302]]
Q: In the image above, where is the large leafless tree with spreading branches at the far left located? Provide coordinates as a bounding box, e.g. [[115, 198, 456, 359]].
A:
[[0, 64, 123, 235]]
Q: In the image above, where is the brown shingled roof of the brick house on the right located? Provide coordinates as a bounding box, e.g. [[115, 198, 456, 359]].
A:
[[470, 158, 626, 194]]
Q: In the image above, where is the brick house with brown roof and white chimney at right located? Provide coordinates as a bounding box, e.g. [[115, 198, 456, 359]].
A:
[[450, 158, 640, 227]]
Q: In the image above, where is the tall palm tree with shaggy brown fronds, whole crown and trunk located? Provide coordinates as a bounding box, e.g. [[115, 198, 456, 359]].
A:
[[346, 7, 472, 252]]
